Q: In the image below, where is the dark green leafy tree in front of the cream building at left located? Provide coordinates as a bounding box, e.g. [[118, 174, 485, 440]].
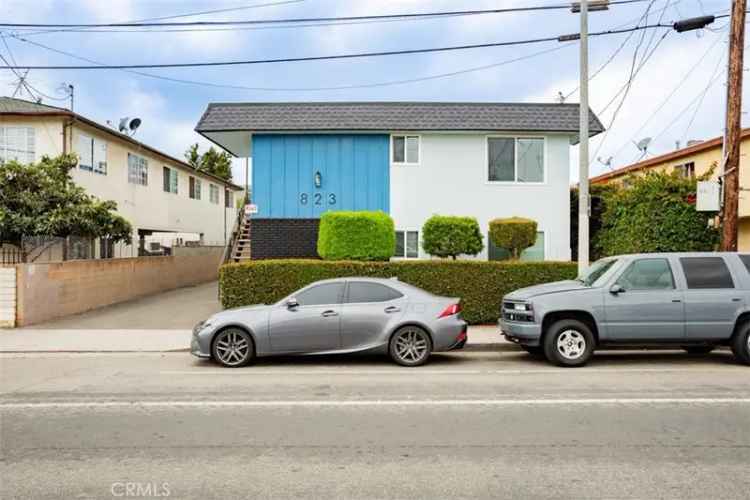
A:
[[0, 155, 132, 244]]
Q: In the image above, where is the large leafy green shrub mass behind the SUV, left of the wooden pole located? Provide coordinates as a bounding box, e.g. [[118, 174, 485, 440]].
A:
[[594, 169, 719, 256]]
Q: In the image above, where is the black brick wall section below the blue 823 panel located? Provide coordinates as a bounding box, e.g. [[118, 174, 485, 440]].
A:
[[250, 219, 320, 259]]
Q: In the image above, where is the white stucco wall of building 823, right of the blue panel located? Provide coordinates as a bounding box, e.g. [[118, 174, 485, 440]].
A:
[[390, 133, 570, 260]]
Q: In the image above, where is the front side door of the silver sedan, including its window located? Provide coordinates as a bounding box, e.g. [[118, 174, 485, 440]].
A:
[[269, 282, 344, 353]]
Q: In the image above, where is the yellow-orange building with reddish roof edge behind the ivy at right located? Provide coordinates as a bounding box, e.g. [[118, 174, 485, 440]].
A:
[[590, 128, 750, 251]]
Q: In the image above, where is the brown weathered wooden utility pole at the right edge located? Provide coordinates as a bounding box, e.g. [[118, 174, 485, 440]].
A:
[[721, 0, 747, 252]]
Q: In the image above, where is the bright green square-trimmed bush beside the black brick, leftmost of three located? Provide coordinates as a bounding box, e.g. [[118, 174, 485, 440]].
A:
[[318, 211, 396, 260]]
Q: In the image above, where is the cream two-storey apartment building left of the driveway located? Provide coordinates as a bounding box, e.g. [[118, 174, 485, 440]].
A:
[[0, 97, 241, 257]]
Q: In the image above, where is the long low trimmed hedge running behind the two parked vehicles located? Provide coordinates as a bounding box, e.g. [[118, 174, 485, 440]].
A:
[[219, 259, 576, 324]]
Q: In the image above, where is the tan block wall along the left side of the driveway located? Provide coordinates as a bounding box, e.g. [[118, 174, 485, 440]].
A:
[[16, 247, 223, 326]]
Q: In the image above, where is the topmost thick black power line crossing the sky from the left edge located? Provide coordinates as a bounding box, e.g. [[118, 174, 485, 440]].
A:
[[0, 0, 647, 29]]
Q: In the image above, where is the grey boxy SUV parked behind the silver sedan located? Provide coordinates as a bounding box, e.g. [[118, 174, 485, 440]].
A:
[[499, 253, 750, 366]]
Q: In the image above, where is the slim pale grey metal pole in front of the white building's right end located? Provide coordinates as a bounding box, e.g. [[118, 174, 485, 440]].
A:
[[578, 0, 590, 275]]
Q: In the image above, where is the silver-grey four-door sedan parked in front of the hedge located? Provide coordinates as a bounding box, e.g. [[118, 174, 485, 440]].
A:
[[191, 278, 467, 367]]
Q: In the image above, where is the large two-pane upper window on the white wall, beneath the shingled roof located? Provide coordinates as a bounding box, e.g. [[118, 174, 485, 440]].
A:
[[487, 137, 544, 183]]
